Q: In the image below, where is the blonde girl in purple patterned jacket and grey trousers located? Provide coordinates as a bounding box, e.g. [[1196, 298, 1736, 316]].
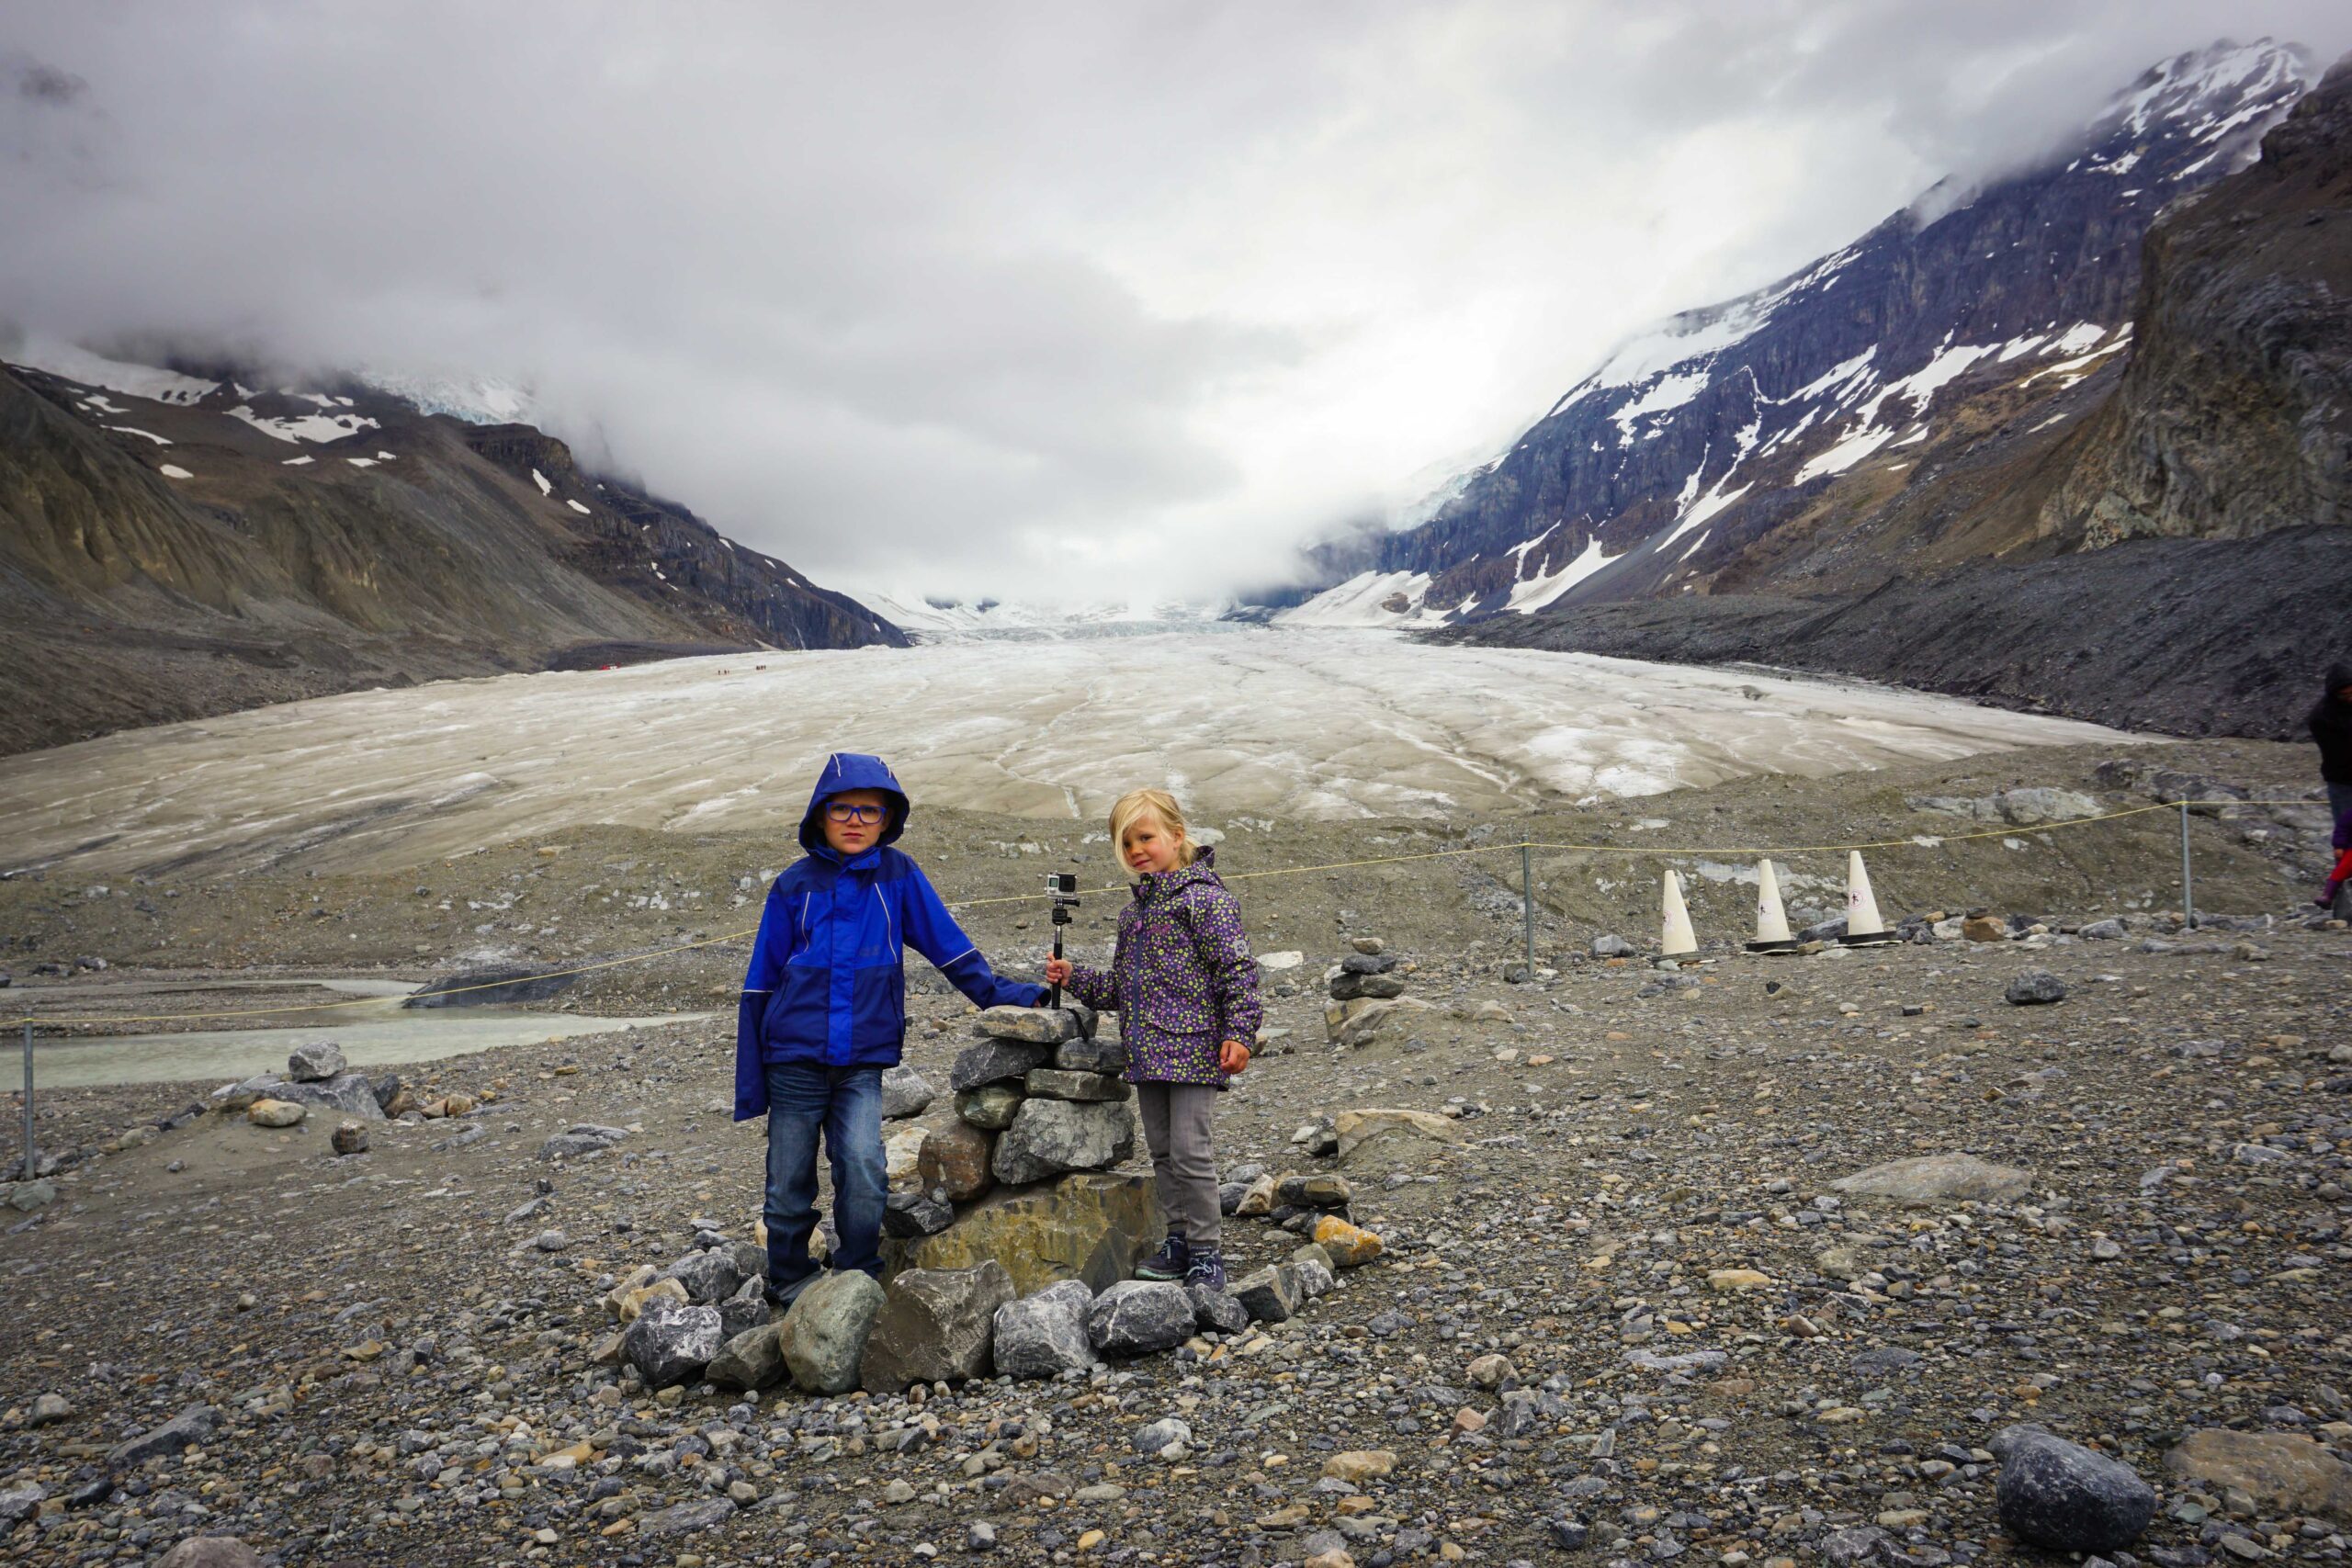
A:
[[1046, 790, 1259, 1291]]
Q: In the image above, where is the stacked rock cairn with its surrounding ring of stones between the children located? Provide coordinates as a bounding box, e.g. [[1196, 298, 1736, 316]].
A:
[[595, 1001, 1383, 1399]]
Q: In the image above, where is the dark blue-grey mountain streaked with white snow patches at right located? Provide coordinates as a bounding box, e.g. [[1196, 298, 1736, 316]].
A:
[[1275, 40, 2314, 626]]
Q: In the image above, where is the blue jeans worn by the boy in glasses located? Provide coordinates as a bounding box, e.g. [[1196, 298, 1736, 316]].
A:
[[764, 1063, 889, 1300]]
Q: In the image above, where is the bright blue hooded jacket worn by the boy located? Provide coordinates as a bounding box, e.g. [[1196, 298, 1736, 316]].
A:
[[736, 752, 1046, 1122]]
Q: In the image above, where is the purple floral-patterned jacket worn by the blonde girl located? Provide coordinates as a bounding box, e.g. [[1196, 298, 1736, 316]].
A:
[[1070, 849, 1263, 1089]]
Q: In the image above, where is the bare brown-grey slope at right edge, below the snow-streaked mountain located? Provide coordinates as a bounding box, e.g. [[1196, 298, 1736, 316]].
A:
[[1446, 59, 2352, 739]]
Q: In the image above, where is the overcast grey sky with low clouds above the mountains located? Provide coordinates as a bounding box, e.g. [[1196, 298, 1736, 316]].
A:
[[0, 0, 2352, 600]]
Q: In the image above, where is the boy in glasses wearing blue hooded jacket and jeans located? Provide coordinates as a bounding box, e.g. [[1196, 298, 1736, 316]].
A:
[[736, 752, 1046, 1307]]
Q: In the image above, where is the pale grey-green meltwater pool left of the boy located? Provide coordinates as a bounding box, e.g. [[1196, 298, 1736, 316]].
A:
[[33, 1010, 718, 1093]]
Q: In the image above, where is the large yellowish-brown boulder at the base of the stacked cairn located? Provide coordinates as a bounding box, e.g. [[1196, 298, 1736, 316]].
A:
[[882, 1173, 1167, 1295]]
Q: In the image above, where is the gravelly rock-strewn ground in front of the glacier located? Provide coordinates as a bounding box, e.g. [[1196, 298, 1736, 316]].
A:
[[0, 743, 2352, 1568]]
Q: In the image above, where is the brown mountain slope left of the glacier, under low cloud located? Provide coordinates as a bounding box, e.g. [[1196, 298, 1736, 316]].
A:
[[0, 348, 906, 752]]
